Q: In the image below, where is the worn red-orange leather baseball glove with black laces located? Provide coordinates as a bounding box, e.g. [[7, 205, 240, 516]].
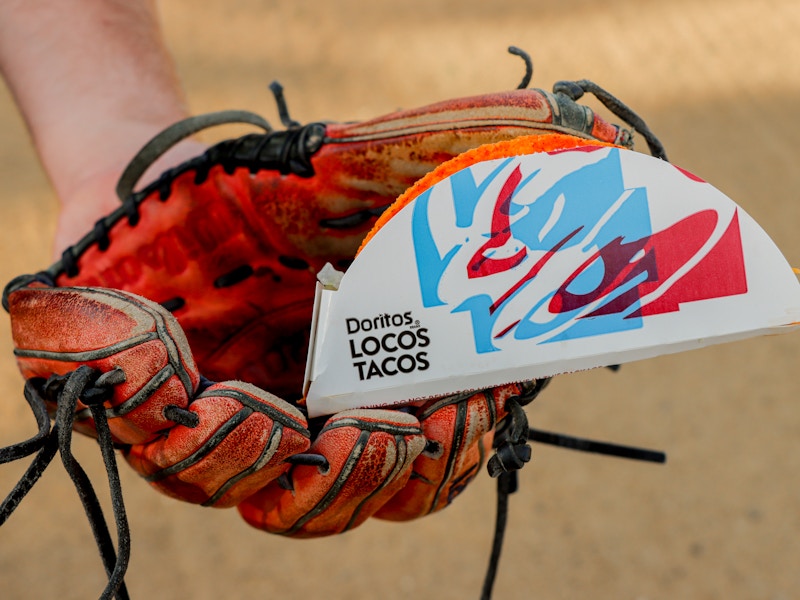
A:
[[0, 49, 663, 595]]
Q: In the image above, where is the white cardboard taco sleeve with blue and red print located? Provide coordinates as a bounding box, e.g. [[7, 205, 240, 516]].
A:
[[306, 147, 800, 416]]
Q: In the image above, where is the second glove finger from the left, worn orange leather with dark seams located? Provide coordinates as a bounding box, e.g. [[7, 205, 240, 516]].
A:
[[125, 381, 311, 507]]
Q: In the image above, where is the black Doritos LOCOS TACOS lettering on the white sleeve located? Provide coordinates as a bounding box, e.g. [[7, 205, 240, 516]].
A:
[[345, 311, 431, 381]]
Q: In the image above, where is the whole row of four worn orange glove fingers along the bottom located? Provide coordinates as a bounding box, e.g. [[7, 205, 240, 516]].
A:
[[9, 288, 544, 537]]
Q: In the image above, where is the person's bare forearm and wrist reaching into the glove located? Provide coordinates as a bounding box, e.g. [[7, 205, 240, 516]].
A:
[[0, 0, 203, 256]]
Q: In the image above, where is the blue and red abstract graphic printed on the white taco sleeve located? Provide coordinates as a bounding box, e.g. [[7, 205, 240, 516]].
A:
[[412, 147, 747, 353]]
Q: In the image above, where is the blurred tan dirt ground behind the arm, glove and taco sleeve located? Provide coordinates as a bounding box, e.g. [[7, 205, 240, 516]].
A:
[[0, 0, 800, 600]]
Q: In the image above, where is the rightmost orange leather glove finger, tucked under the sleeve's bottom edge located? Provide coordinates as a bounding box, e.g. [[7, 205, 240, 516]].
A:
[[375, 384, 524, 521]]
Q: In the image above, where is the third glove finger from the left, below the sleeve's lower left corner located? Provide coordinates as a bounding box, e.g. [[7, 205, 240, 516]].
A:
[[239, 410, 425, 538]]
